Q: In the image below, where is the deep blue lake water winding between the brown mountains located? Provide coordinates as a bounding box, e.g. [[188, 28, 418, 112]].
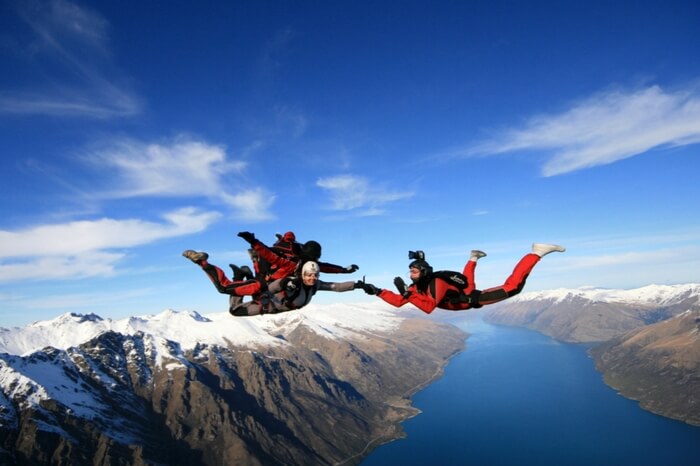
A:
[[362, 314, 700, 466]]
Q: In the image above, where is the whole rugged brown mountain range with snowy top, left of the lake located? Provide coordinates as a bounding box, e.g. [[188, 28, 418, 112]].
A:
[[0, 305, 465, 465]]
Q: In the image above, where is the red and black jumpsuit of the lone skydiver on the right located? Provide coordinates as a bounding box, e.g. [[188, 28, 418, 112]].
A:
[[377, 253, 540, 314]]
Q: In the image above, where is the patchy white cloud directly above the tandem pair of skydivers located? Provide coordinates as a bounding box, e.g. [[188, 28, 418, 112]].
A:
[[85, 137, 275, 221]]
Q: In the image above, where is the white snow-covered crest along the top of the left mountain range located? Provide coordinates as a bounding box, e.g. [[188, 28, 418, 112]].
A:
[[0, 303, 402, 355]]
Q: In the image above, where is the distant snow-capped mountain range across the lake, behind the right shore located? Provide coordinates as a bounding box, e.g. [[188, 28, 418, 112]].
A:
[[485, 283, 700, 342]]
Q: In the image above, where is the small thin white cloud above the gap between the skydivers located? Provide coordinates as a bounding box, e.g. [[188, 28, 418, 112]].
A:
[[316, 175, 413, 216]]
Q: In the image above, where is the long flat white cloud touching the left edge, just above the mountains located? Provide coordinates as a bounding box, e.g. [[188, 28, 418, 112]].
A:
[[0, 208, 220, 282]]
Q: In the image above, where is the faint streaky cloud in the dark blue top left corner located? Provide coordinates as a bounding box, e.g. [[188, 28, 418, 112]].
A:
[[0, 0, 141, 118]]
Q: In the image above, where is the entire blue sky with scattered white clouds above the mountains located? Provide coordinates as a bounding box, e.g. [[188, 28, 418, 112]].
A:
[[0, 0, 700, 327]]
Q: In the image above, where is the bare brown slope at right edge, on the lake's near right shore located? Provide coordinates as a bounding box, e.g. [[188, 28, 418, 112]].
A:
[[590, 311, 700, 426]]
